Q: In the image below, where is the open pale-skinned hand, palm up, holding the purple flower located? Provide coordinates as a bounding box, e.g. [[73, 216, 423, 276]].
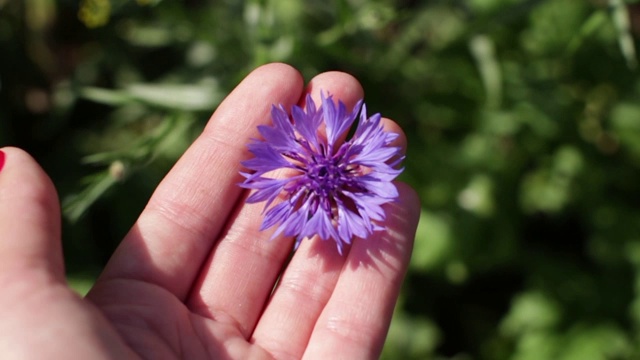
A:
[[0, 64, 420, 359]]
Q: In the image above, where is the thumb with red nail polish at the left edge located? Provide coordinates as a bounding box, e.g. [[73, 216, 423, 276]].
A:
[[0, 147, 65, 288]]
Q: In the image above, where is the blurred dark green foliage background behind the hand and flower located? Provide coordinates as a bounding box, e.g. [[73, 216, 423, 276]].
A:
[[0, 0, 640, 360]]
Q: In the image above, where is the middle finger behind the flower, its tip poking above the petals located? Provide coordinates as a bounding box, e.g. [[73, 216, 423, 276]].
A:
[[189, 72, 362, 337]]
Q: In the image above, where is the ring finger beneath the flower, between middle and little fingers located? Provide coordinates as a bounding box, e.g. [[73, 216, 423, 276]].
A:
[[252, 114, 406, 359]]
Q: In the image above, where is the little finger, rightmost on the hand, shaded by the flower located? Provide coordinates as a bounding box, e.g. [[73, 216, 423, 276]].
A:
[[304, 183, 420, 359]]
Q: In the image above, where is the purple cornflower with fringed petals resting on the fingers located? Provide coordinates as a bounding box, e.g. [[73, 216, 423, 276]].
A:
[[240, 94, 404, 254]]
